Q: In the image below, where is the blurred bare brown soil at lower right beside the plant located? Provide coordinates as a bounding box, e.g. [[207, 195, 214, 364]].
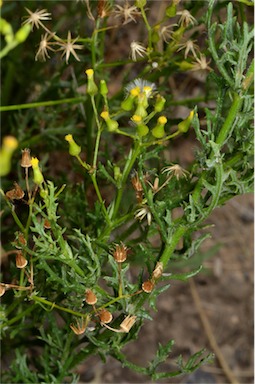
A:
[[76, 195, 253, 384]]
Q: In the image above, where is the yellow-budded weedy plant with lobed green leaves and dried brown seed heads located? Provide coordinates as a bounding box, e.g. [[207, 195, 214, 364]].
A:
[[0, 0, 254, 383]]
